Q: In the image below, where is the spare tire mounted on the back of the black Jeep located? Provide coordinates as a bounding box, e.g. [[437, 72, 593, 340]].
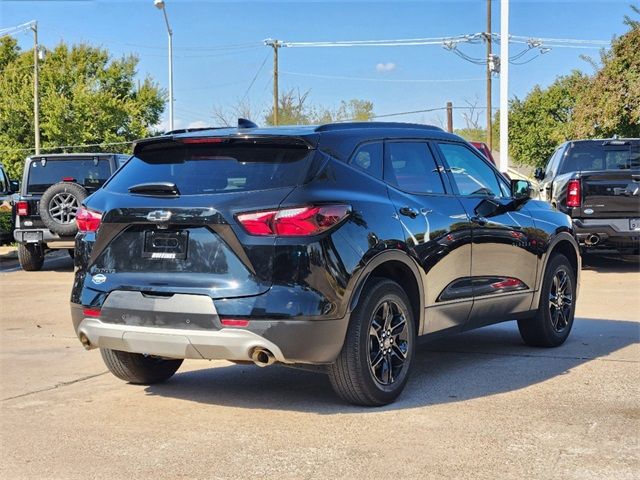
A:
[[39, 182, 89, 237]]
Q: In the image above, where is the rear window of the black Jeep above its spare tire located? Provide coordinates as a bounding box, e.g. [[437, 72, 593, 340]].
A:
[[27, 159, 111, 193]]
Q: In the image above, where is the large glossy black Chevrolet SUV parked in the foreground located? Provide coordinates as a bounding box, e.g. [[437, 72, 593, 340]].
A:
[[71, 123, 580, 405]]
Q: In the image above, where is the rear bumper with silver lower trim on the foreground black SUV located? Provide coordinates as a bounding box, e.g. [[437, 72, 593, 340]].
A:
[[71, 303, 349, 364]]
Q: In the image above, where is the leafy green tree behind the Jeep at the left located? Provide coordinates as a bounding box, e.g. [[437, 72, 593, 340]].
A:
[[0, 37, 166, 177]]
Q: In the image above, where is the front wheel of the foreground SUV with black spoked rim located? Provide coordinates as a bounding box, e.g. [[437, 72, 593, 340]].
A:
[[518, 254, 576, 347]]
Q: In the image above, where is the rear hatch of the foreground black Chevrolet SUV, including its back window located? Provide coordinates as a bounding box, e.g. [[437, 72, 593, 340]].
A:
[[87, 139, 313, 298]]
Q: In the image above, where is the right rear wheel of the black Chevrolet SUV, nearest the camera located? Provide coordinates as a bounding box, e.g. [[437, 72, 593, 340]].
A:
[[328, 278, 416, 406]]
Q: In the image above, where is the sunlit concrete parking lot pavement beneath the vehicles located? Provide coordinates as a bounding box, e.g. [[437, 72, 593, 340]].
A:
[[0, 252, 640, 480]]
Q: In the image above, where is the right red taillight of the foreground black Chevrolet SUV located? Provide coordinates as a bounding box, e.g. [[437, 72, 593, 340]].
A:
[[236, 205, 351, 237]]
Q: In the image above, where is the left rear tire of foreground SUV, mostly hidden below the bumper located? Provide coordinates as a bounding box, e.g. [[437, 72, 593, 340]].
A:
[[100, 348, 182, 385]]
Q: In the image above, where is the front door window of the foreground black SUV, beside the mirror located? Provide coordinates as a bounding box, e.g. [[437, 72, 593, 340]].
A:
[[438, 143, 504, 197]]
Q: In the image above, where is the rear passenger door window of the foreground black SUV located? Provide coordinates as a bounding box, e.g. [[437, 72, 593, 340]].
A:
[[385, 142, 444, 193]]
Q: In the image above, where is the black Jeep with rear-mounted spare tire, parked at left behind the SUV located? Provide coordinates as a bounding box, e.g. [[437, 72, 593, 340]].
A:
[[14, 153, 130, 271]]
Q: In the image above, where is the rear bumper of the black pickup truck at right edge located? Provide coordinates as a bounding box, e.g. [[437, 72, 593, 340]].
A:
[[573, 218, 640, 248]]
